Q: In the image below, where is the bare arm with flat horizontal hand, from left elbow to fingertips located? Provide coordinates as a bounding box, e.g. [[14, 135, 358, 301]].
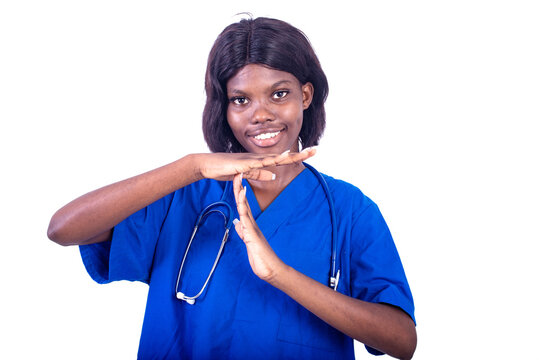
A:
[[47, 150, 315, 246]]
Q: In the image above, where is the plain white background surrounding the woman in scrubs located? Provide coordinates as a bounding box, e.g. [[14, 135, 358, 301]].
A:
[[0, 0, 539, 359]]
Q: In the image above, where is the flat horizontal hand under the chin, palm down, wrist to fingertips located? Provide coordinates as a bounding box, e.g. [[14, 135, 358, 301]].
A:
[[192, 148, 316, 181]]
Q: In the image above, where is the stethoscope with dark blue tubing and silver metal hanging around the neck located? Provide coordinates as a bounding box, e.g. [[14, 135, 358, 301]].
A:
[[175, 163, 341, 305]]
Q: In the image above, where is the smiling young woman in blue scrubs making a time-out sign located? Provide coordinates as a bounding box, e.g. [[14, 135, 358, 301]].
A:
[[48, 18, 416, 359]]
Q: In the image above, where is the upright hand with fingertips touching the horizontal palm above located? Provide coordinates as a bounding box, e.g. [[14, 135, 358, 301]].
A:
[[234, 174, 286, 282]]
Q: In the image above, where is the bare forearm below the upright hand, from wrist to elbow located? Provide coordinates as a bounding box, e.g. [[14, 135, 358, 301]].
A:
[[269, 265, 417, 359]]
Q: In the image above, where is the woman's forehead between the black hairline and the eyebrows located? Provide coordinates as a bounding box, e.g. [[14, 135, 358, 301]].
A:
[[226, 64, 300, 91]]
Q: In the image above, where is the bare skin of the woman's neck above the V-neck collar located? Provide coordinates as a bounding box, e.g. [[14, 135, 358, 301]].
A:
[[249, 163, 305, 211]]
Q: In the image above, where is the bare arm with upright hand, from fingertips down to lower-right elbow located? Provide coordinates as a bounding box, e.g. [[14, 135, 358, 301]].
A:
[[234, 174, 417, 359]]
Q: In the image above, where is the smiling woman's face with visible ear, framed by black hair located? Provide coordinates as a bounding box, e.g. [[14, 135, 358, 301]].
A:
[[226, 64, 313, 154]]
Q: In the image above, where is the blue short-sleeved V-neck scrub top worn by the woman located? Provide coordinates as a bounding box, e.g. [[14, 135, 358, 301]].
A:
[[80, 169, 415, 359]]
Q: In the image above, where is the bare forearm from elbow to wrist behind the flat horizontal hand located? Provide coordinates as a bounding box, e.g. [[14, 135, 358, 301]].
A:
[[47, 155, 200, 245]]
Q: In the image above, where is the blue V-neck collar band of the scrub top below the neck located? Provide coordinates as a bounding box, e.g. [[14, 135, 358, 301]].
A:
[[238, 168, 320, 239]]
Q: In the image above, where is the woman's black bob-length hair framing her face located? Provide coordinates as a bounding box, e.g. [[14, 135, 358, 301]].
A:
[[202, 17, 329, 152]]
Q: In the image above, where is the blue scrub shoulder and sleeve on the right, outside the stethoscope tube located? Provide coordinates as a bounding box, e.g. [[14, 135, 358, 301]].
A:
[[330, 175, 415, 355]]
